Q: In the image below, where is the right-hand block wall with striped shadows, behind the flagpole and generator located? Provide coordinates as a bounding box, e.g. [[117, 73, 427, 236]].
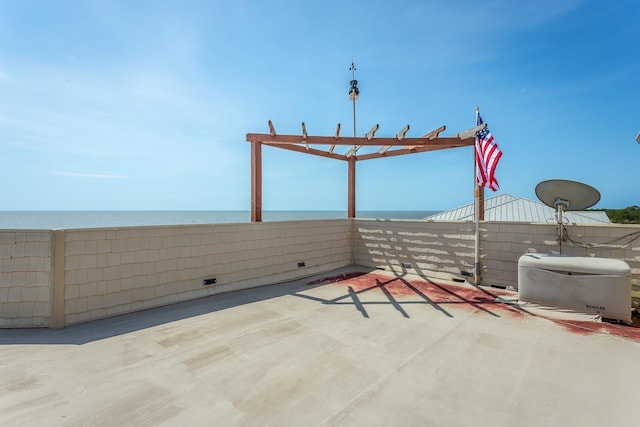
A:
[[354, 219, 640, 291]]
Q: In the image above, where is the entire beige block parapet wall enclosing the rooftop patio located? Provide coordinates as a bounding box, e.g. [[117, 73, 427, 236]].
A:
[[0, 219, 640, 327]]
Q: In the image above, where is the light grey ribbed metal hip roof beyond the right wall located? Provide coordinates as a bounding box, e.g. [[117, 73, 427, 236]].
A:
[[425, 194, 611, 224]]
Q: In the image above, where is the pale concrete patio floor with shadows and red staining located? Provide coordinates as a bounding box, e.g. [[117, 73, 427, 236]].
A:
[[0, 266, 640, 426]]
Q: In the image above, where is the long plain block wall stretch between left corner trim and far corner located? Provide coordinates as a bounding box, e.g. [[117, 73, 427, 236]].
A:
[[64, 220, 351, 325]]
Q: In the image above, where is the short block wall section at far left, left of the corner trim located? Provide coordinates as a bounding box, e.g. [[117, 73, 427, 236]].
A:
[[0, 230, 52, 328]]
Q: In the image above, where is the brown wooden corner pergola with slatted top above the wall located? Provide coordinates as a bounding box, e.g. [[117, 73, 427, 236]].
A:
[[247, 120, 487, 222]]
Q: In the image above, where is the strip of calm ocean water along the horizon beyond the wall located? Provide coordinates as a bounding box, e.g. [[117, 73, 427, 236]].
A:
[[0, 211, 439, 230]]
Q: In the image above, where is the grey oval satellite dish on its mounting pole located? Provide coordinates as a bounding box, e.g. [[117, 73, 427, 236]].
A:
[[536, 179, 600, 253]]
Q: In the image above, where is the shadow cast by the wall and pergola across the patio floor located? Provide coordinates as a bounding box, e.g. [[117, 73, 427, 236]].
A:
[[5, 266, 640, 345]]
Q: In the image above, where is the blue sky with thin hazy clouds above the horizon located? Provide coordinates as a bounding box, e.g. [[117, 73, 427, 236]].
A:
[[0, 0, 640, 210]]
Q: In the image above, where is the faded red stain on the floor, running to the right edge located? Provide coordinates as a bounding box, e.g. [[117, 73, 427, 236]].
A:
[[309, 272, 640, 341]]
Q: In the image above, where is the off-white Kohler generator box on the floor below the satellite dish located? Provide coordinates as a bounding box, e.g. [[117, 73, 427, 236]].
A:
[[518, 253, 631, 322]]
